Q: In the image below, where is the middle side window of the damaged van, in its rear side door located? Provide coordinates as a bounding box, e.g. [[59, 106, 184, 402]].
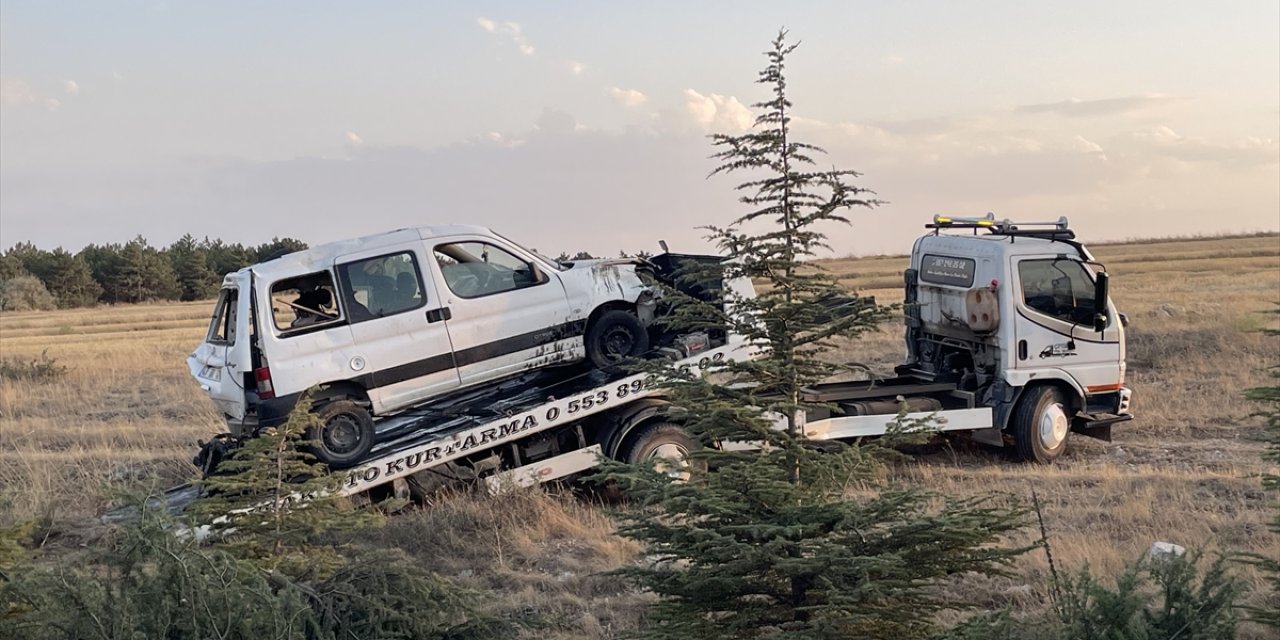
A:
[[338, 251, 426, 323]]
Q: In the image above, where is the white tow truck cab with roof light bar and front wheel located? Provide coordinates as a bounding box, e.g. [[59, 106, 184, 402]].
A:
[[850, 214, 1133, 462]]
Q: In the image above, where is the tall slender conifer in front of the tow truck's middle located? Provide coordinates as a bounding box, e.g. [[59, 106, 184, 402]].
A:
[[603, 32, 1024, 639]]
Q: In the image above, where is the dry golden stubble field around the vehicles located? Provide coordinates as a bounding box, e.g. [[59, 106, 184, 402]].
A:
[[0, 234, 1280, 637]]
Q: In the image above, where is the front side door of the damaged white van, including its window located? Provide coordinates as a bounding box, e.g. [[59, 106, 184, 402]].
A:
[[431, 238, 582, 387]]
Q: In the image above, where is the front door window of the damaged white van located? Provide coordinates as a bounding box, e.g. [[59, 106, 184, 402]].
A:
[[435, 242, 541, 298]]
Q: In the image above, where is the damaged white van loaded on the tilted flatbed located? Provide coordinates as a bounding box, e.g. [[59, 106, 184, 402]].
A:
[[187, 225, 657, 467]]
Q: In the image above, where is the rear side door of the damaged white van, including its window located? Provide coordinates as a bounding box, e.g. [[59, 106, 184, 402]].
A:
[[338, 242, 458, 413]]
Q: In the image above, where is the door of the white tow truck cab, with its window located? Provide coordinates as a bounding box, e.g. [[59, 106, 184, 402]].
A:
[[1012, 256, 1124, 394]]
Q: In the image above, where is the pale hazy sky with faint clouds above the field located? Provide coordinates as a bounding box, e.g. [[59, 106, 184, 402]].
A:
[[0, 0, 1280, 256]]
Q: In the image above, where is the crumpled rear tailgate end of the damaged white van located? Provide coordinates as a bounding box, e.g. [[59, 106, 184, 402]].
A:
[[187, 271, 253, 420]]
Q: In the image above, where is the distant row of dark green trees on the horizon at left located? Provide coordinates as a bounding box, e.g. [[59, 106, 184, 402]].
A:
[[0, 234, 307, 311]]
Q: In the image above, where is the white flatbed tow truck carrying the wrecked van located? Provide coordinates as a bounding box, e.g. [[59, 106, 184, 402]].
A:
[[124, 214, 1133, 508]]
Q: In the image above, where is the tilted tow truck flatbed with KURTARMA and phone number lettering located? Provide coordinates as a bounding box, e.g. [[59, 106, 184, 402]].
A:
[[115, 343, 1034, 522]]
